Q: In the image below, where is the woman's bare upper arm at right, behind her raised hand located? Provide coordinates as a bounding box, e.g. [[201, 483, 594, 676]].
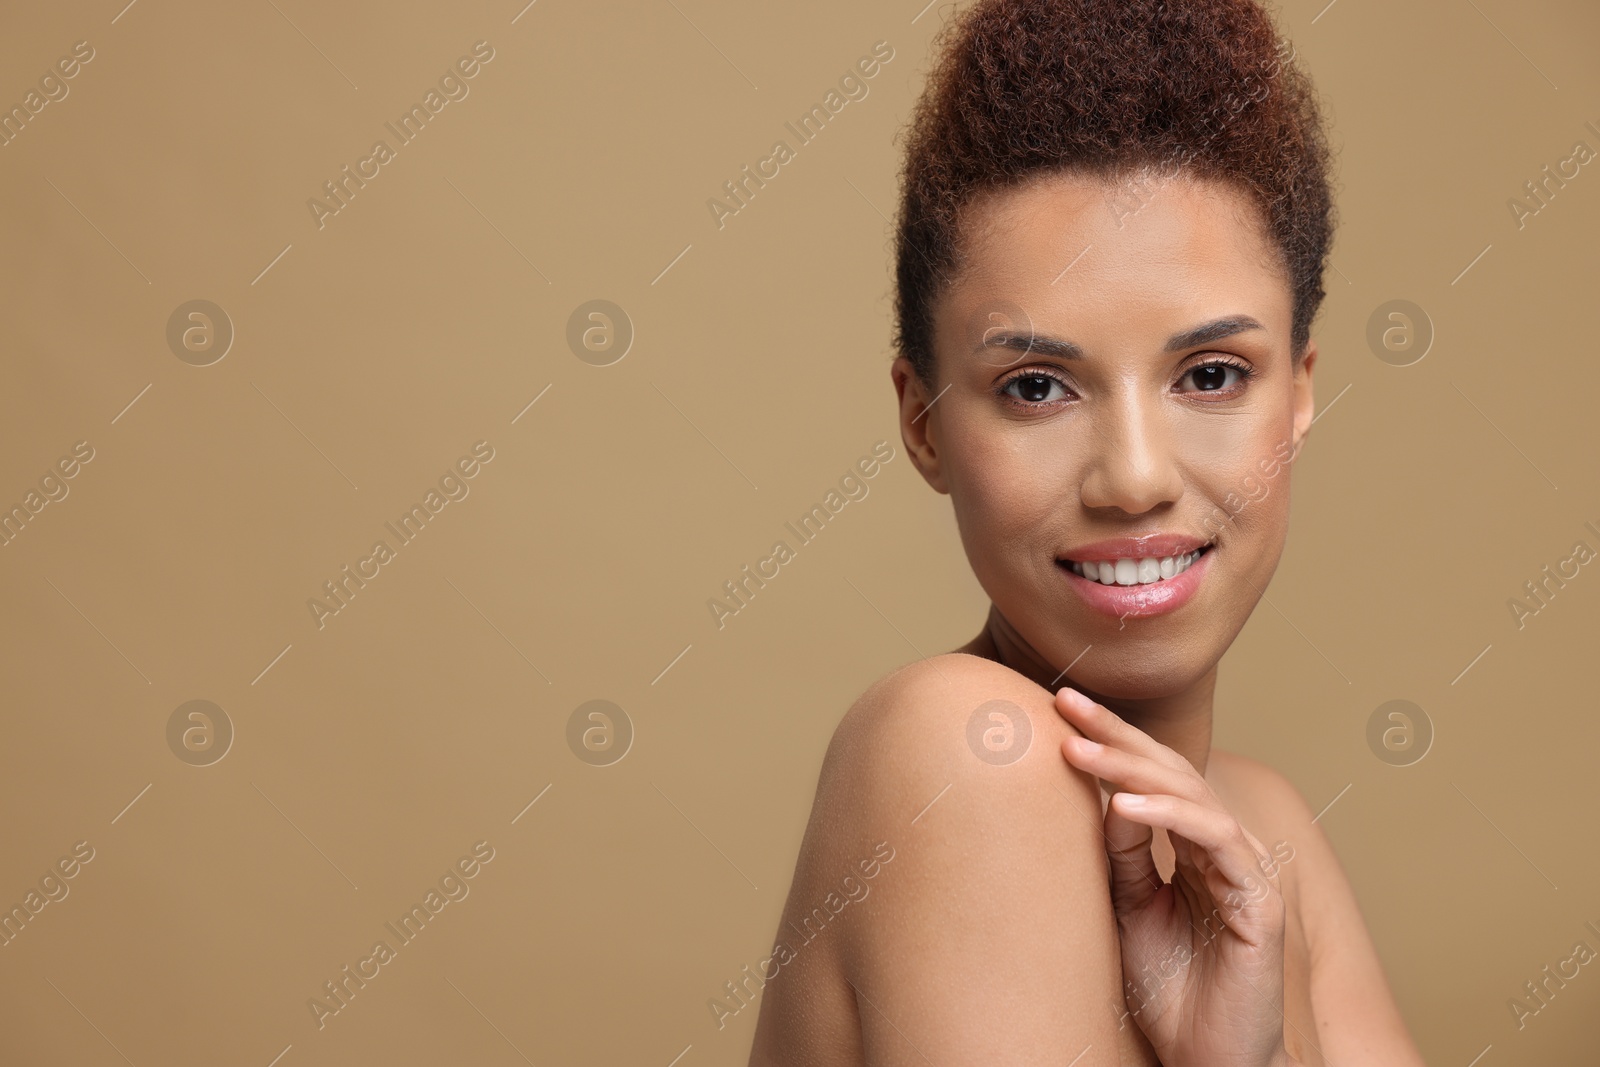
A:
[[1254, 763, 1426, 1067]]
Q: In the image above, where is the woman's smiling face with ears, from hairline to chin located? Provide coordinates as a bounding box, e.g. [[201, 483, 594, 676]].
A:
[[894, 174, 1315, 699]]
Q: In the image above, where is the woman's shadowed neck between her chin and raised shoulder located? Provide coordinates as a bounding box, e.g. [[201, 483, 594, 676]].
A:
[[957, 603, 1216, 774]]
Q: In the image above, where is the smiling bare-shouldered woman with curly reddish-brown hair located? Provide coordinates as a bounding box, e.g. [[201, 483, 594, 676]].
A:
[[746, 0, 1422, 1067]]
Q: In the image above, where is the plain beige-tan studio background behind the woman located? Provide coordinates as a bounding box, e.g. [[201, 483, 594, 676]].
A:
[[0, 0, 1600, 1067]]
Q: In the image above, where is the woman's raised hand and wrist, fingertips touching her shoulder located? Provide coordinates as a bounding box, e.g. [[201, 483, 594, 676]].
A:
[[1056, 689, 1288, 1067]]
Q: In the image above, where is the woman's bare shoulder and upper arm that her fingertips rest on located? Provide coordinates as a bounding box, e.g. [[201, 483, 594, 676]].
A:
[[808, 656, 1133, 1067]]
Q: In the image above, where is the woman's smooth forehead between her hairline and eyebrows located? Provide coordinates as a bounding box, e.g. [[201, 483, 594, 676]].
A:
[[939, 173, 1291, 344]]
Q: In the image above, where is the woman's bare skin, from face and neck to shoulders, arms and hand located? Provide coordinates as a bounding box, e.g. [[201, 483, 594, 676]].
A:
[[747, 173, 1422, 1067]]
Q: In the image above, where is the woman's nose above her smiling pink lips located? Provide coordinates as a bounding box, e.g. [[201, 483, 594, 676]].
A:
[[1078, 397, 1184, 515]]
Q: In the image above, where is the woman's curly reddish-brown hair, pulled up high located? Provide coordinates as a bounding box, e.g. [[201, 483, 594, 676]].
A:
[[894, 0, 1334, 384]]
